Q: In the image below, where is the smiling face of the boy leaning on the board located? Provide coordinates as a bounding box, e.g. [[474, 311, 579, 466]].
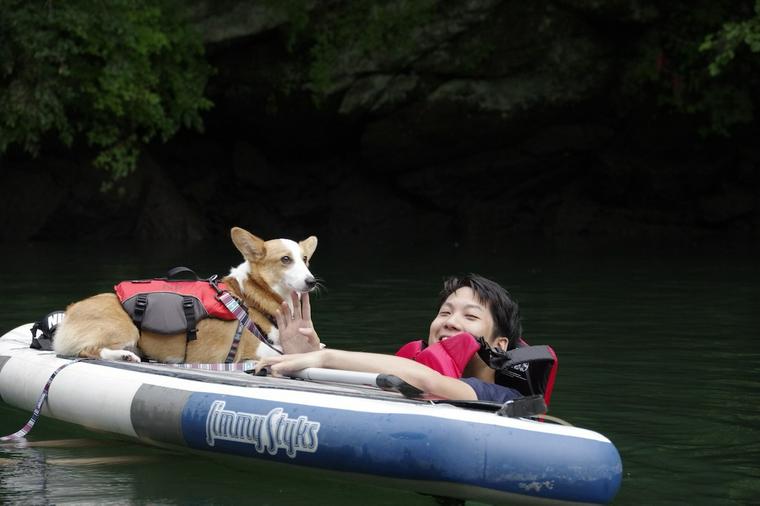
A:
[[428, 287, 494, 346]]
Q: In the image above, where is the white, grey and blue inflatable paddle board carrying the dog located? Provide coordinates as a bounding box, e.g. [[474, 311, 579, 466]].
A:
[[0, 325, 622, 504]]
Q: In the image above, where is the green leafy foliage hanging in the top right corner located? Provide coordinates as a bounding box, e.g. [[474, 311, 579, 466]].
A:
[[624, 0, 760, 136]]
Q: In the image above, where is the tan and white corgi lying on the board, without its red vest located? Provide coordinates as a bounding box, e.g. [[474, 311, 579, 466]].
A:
[[53, 227, 317, 363]]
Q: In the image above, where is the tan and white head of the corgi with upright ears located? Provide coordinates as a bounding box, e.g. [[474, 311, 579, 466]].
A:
[[230, 227, 317, 298]]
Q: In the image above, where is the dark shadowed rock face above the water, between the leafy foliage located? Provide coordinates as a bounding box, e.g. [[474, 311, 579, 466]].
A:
[[3, 0, 760, 244]]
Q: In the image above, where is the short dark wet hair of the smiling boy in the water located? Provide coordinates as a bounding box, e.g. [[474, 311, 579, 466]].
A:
[[438, 274, 522, 349]]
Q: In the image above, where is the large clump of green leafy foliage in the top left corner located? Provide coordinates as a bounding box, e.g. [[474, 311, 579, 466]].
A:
[[0, 0, 211, 179]]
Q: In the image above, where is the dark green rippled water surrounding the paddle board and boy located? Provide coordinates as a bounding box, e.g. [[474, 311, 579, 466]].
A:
[[0, 240, 760, 505]]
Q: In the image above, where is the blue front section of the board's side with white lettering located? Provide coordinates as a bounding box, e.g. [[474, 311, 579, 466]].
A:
[[181, 393, 622, 503]]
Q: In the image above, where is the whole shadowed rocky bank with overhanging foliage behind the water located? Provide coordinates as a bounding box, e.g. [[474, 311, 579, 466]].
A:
[[0, 0, 760, 245]]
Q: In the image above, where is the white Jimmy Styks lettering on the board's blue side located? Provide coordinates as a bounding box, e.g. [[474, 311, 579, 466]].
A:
[[206, 400, 319, 458]]
